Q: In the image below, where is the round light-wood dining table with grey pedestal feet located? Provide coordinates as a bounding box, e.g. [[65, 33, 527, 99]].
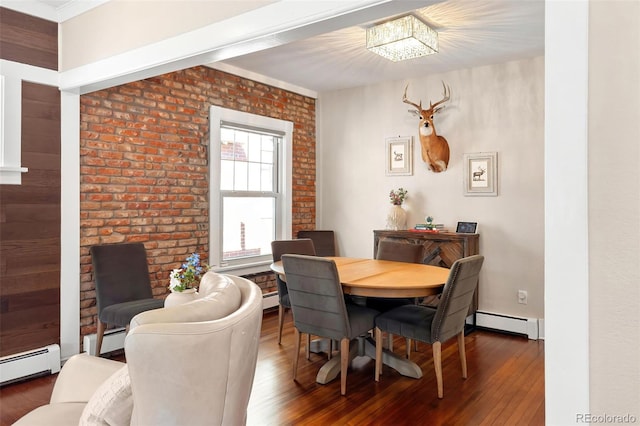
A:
[[271, 257, 449, 384]]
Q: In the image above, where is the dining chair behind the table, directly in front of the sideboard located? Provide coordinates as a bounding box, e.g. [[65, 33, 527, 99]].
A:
[[366, 239, 424, 312]]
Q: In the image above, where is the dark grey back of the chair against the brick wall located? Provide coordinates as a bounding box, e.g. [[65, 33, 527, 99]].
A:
[[89, 243, 153, 313]]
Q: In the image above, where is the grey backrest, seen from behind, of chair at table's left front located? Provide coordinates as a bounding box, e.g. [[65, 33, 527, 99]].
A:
[[282, 254, 350, 340]]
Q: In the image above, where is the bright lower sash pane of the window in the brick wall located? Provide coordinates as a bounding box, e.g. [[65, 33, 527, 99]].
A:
[[222, 197, 275, 260]]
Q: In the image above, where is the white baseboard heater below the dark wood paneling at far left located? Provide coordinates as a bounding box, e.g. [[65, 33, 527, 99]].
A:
[[0, 345, 60, 384]]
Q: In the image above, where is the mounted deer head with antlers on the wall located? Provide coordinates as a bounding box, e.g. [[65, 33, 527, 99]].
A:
[[402, 81, 451, 173]]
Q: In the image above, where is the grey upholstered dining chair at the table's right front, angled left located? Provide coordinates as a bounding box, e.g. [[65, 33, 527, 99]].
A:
[[375, 255, 484, 398]]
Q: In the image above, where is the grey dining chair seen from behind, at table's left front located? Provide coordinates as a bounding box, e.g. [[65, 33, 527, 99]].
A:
[[282, 254, 378, 395]]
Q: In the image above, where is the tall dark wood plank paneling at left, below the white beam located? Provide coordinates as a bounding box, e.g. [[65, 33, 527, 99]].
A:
[[0, 82, 60, 356]]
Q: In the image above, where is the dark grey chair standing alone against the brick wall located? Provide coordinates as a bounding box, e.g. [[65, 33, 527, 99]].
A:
[[89, 243, 164, 356]]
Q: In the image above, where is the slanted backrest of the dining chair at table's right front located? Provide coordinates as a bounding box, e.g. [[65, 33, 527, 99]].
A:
[[431, 255, 484, 342]]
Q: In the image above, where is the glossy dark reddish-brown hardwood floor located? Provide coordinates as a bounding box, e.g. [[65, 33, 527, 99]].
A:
[[0, 312, 544, 426]]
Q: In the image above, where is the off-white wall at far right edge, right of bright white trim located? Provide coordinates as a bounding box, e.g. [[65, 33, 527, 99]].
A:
[[588, 1, 640, 416]]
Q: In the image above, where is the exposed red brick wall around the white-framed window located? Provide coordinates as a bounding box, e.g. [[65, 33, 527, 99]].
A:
[[80, 67, 316, 336]]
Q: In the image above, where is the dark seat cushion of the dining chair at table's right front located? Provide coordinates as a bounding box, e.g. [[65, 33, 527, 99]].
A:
[[376, 305, 436, 343]]
